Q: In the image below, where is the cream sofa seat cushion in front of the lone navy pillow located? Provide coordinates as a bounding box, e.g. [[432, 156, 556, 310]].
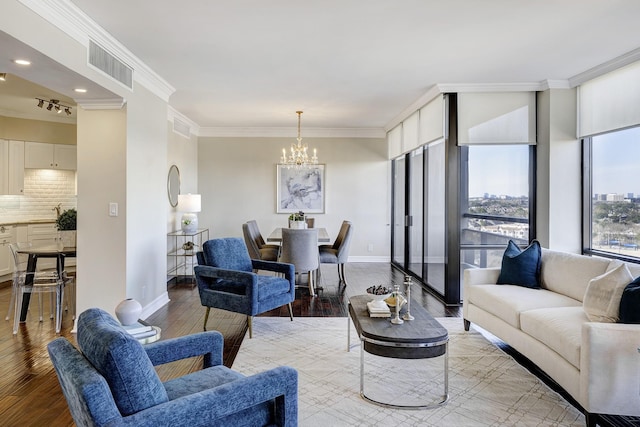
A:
[[464, 285, 582, 329]]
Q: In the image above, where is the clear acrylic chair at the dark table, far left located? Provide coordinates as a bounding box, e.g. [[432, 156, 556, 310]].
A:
[[7, 243, 75, 335]]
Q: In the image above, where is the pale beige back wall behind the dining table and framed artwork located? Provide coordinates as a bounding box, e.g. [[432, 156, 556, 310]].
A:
[[198, 138, 391, 261]]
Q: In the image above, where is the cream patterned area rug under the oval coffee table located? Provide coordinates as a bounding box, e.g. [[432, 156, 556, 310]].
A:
[[233, 317, 585, 427]]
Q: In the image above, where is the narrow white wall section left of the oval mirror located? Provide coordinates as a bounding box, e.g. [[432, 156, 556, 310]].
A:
[[125, 85, 169, 318]]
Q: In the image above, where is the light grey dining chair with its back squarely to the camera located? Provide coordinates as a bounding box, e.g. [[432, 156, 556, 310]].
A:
[[279, 228, 320, 296]]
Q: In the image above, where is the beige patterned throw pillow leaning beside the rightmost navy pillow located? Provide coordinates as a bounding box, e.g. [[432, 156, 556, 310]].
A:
[[583, 264, 633, 322]]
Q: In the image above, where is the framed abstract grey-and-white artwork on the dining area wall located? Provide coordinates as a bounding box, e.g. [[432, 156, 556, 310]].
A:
[[276, 164, 326, 214]]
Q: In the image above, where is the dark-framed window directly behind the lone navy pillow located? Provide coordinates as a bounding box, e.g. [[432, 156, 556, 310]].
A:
[[460, 144, 535, 269]]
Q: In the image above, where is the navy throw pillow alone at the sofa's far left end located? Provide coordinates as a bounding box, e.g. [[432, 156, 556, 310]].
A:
[[497, 240, 542, 288]]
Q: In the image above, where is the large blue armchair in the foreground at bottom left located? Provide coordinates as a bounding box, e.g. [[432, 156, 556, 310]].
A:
[[47, 308, 298, 427]]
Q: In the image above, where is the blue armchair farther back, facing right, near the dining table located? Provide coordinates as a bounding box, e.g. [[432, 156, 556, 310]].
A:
[[194, 237, 296, 338]]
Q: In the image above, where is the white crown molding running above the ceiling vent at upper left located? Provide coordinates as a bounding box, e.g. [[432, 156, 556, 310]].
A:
[[19, 0, 175, 102]]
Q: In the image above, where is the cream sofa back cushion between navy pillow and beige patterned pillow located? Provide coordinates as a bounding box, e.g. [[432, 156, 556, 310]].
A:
[[541, 249, 611, 301]]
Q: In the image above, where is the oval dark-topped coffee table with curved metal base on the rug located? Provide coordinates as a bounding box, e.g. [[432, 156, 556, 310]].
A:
[[347, 295, 449, 409]]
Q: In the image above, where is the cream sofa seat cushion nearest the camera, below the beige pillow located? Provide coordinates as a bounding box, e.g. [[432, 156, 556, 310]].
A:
[[520, 307, 589, 369]]
